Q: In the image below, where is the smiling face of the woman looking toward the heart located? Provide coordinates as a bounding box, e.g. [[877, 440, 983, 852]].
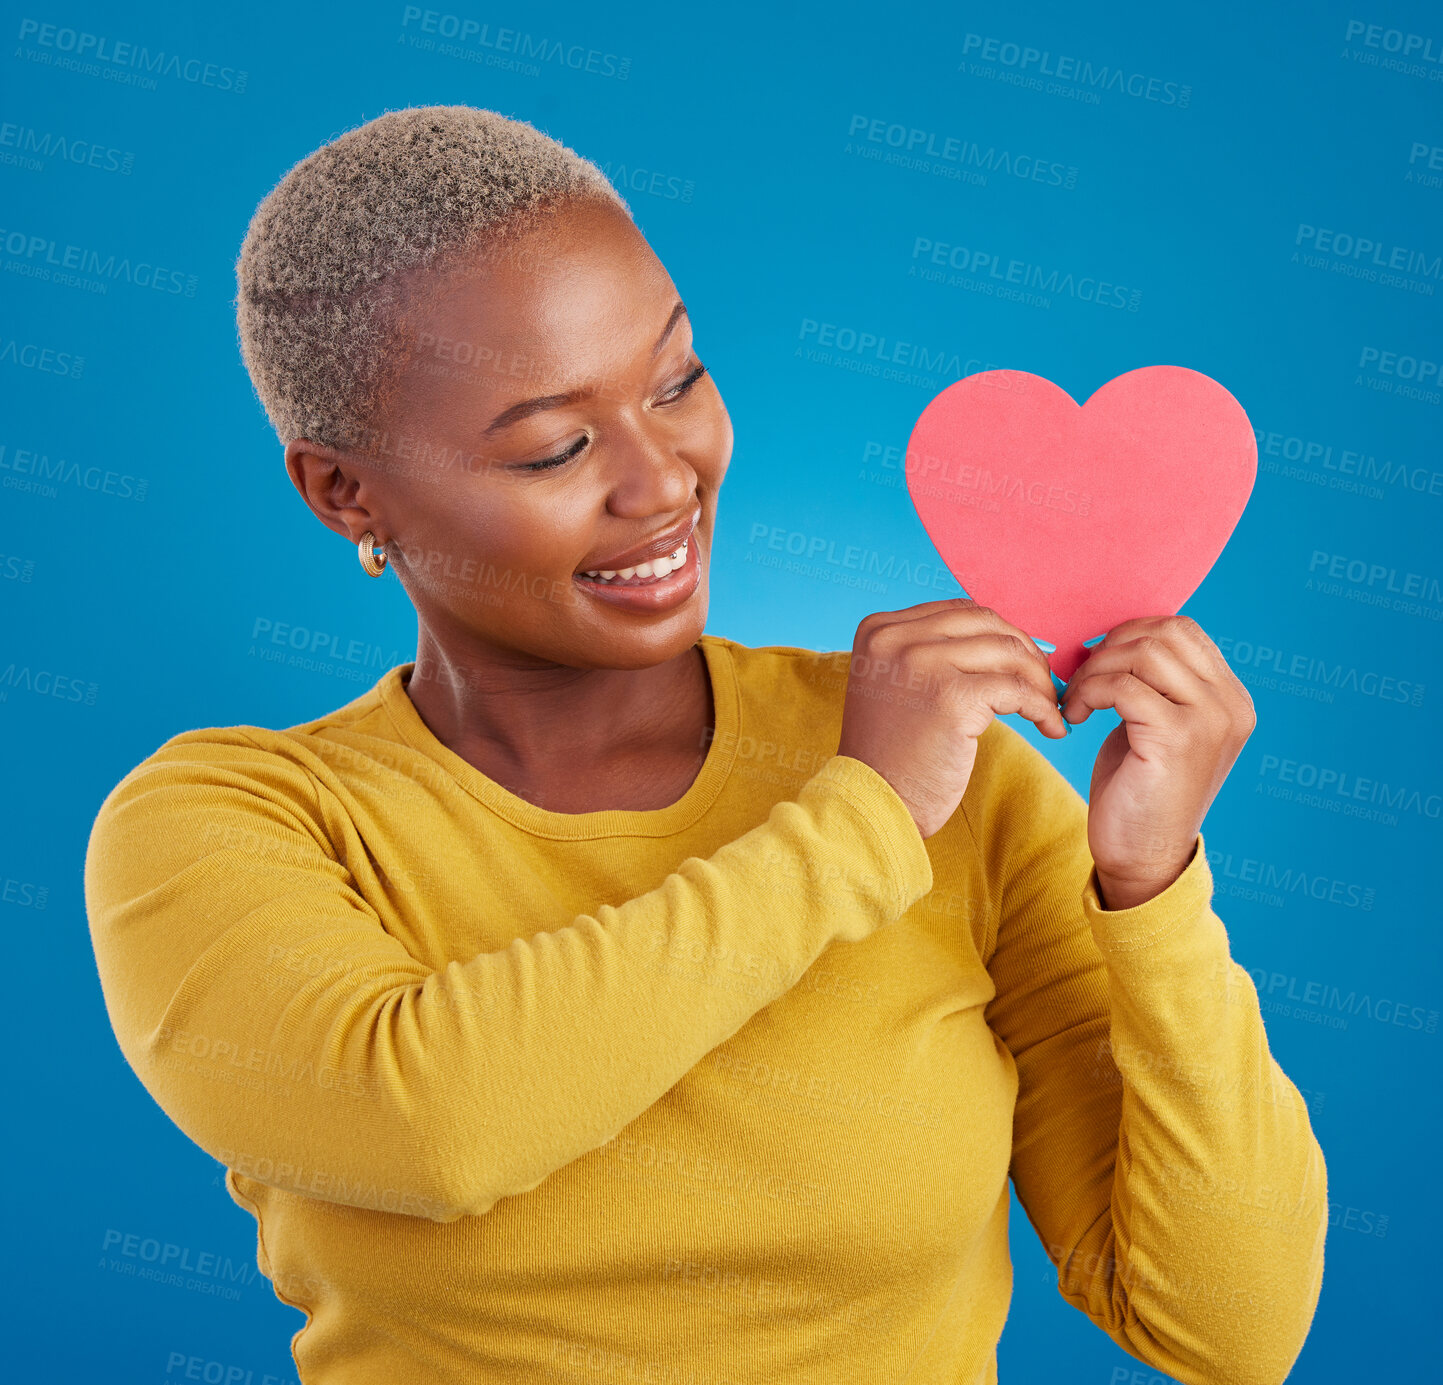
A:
[[301, 194, 732, 668]]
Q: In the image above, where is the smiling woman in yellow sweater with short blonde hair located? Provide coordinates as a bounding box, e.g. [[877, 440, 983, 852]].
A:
[[85, 107, 1326, 1385]]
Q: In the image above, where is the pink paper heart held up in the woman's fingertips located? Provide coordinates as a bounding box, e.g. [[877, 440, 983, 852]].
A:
[[905, 365, 1257, 681]]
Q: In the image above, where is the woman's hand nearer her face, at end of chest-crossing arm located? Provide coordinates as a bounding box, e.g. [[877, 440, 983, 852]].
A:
[[837, 597, 1068, 838]]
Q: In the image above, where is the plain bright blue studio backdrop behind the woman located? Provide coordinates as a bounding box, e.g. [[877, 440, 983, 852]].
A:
[[0, 0, 1443, 1385]]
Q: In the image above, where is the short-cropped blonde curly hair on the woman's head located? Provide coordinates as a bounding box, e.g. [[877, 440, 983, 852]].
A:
[[235, 105, 631, 449]]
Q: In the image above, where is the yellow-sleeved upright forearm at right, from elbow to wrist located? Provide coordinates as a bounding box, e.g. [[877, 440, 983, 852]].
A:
[[1059, 848, 1328, 1382]]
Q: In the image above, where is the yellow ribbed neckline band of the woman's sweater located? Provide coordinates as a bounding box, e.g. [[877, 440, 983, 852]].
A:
[[378, 635, 742, 841]]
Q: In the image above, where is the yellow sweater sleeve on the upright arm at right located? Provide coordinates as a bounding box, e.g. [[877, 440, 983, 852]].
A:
[[968, 723, 1328, 1385]]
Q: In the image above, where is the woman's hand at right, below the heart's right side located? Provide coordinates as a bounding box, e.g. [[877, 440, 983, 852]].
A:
[[1061, 616, 1257, 909]]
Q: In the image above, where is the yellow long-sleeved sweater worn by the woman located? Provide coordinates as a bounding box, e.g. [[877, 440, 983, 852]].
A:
[[85, 635, 1328, 1385]]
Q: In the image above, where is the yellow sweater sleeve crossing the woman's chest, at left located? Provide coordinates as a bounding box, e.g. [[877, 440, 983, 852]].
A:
[[85, 729, 932, 1222]]
